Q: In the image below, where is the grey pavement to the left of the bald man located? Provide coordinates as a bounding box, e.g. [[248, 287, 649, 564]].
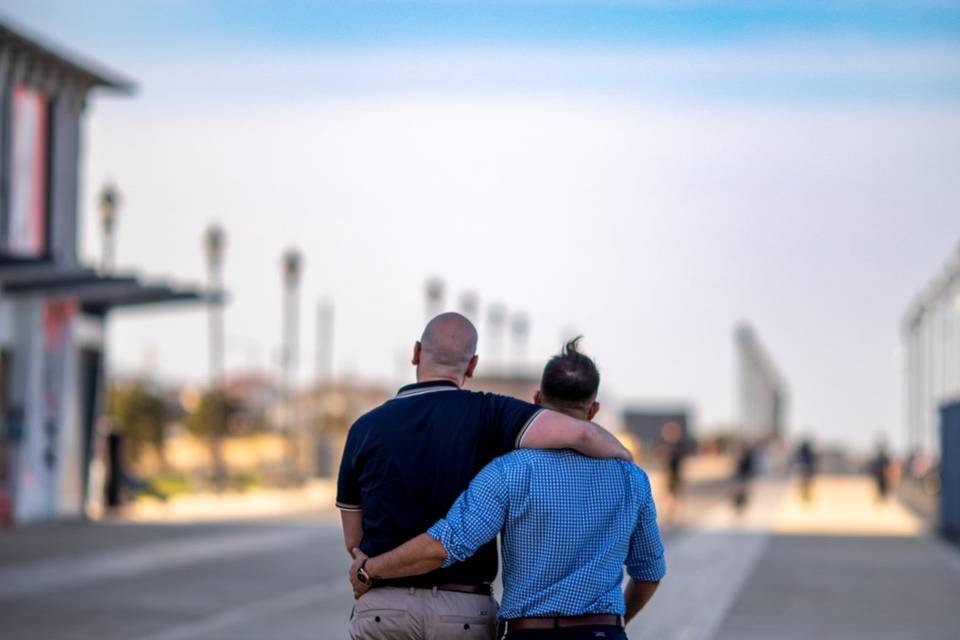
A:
[[0, 515, 352, 640]]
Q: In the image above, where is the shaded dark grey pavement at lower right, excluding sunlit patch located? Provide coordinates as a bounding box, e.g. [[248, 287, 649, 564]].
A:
[[713, 535, 960, 640]]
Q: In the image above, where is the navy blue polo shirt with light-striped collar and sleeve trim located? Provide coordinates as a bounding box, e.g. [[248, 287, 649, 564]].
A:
[[337, 381, 541, 587]]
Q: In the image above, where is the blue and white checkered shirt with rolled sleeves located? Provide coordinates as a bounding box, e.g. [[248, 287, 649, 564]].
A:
[[427, 449, 666, 620]]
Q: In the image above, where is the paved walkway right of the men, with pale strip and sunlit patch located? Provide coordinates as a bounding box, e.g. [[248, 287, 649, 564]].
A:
[[628, 477, 960, 640]]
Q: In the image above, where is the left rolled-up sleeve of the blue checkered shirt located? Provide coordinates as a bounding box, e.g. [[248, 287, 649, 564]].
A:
[[427, 460, 509, 567]]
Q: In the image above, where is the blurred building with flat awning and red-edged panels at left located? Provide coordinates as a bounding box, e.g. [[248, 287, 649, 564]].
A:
[[0, 19, 212, 524]]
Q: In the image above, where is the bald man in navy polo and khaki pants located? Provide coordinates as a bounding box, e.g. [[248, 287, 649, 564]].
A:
[[337, 313, 631, 640]]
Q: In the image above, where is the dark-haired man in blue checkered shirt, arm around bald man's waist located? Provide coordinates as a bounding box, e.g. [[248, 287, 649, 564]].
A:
[[352, 340, 665, 640]]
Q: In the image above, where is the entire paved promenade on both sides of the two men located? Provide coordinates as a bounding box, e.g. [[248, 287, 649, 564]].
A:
[[0, 478, 960, 640]]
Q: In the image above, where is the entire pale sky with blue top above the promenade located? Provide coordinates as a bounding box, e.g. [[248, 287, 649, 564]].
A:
[[0, 0, 960, 446]]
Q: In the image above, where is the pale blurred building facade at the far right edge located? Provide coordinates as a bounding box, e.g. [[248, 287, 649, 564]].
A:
[[901, 242, 960, 458]]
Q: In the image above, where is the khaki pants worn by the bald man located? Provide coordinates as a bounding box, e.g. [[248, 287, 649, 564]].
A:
[[350, 587, 497, 640]]
